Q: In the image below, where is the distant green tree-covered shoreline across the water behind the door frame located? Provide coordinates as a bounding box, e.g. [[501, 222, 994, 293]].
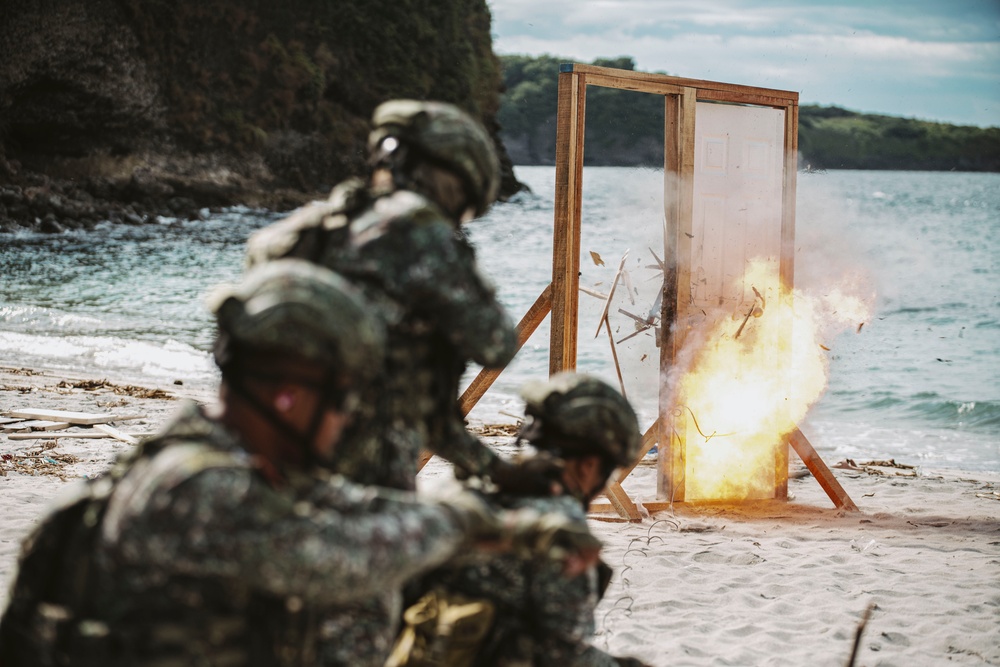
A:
[[498, 55, 1000, 171]]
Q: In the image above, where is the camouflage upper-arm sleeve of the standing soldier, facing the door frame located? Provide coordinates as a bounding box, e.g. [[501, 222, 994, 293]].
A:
[[393, 222, 517, 368]]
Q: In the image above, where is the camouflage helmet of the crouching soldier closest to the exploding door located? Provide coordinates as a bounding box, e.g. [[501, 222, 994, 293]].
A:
[[521, 372, 641, 467]]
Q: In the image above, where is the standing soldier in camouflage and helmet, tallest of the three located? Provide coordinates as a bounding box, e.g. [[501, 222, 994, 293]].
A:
[[247, 100, 549, 490]]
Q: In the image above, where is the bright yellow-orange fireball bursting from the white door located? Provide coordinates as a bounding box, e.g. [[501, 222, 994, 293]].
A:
[[670, 260, 870, 500]]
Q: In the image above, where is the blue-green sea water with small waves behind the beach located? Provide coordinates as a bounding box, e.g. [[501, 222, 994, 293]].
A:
[[0, 167, 1000, 471]]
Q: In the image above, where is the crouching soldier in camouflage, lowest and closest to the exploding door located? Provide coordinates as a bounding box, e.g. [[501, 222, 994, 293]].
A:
[[387, 373, 656, 667]]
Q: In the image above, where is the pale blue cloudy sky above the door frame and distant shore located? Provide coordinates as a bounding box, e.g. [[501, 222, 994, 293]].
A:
[[487, 0, 1000, 127]]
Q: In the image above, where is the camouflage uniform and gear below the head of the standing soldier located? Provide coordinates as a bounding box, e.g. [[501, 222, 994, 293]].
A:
[[247, 164, 516, 489]]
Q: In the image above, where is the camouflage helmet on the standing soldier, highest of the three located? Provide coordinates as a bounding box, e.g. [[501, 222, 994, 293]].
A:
[[368, 100, 500, 216]]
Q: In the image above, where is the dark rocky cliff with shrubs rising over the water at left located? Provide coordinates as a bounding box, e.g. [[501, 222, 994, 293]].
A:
[[0, 0, 516, 231]]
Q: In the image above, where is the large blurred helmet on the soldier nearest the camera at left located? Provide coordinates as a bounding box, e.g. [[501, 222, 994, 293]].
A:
[[207, 259, 385, 385]]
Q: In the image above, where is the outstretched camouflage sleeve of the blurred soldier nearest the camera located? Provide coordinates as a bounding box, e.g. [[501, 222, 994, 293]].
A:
[[104, 467, 463, 604]]
